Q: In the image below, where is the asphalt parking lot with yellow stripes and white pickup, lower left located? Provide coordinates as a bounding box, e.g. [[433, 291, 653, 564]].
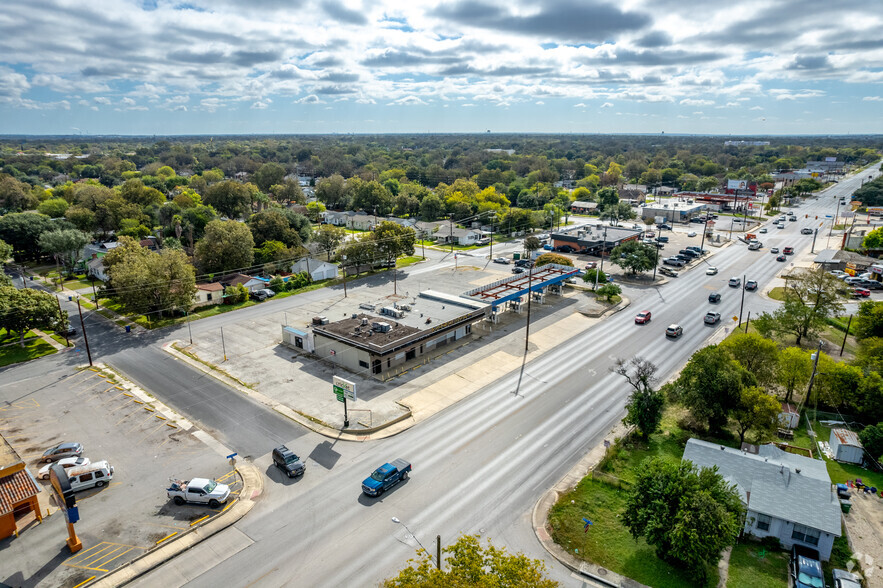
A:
[[0, 369, 241, 587]]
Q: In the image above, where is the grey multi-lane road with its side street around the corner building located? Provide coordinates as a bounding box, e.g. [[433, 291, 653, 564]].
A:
[[6, 168, 867, 586]]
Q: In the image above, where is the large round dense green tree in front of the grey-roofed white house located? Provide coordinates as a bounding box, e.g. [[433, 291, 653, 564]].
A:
[[622, 458, 745, 585]]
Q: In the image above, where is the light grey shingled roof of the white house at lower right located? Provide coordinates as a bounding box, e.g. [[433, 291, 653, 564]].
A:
[[684, 439, 840, 537]]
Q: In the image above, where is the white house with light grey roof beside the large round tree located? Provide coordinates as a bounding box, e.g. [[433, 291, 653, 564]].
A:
[[684, 439, 841, 561]]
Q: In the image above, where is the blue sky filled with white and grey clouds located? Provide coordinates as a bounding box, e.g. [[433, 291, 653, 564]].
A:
[[0, 0, 883, 134]]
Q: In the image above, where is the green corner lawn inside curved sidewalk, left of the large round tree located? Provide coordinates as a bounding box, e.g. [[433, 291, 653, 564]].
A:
[[549, 478, 718, 588]]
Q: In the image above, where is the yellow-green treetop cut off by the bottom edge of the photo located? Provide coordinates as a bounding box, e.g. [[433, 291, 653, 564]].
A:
[[381, 535, 558, 588]]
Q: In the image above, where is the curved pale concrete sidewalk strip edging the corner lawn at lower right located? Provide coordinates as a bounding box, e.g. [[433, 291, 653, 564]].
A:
[[531, 421, 648, 588]]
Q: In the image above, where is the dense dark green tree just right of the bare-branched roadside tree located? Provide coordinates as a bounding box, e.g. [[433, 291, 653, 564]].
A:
[[663, 345, 756, 432]]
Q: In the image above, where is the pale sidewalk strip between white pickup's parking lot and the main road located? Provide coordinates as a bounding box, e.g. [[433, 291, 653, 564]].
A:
[[90, 461, 264, 587]]
